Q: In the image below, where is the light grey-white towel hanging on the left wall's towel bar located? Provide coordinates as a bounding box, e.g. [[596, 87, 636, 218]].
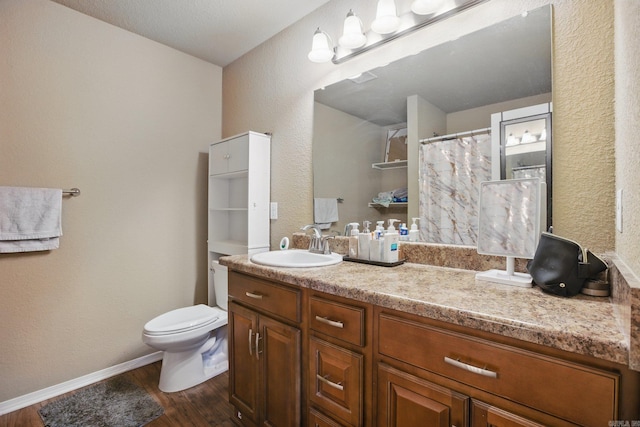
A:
[[0, 187, 62, 253]]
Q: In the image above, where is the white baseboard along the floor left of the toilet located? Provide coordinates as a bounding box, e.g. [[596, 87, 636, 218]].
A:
[[0, 351, 162, 415]]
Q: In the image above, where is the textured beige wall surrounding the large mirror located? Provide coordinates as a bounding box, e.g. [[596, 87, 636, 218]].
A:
[[223, 0, 615, 252]]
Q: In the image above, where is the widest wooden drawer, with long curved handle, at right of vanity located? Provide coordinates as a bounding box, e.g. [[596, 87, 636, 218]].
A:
[[378, 314, 619, 425]]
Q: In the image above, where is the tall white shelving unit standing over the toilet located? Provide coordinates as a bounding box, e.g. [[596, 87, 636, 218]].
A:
[[207, 132, 271, 305]]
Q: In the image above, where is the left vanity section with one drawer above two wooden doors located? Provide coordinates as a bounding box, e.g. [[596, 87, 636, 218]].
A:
[[229, 271, 302, 427]]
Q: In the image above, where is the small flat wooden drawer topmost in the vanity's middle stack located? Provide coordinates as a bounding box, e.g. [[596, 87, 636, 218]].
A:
[[309, 297, 365, 347]]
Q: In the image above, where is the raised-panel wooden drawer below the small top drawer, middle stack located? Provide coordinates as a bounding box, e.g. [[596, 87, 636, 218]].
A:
[[309, 337, 364, 426]]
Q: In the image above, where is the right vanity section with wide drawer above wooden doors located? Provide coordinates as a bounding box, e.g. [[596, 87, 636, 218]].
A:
[[374, 308, 620, 427]]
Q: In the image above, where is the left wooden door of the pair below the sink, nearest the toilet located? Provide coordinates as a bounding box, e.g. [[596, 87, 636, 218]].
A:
[[229, 302, 261, 423]]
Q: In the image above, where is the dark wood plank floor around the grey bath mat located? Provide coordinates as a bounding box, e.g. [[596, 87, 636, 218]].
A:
[[0, 362, 234, 427]]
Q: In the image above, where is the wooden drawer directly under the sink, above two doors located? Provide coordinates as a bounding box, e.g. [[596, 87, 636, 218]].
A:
[[229, 271, 301, 322]]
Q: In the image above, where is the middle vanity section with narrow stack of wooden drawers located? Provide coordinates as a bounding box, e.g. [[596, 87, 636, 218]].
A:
[[307, 291, 373, 427]]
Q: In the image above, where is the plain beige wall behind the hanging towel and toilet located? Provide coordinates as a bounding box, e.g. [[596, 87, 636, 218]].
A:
[[0, 0, 222, 402]]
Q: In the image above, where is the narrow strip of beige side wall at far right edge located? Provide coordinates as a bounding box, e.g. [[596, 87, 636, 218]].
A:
[[615, 0, 640, 274]]
